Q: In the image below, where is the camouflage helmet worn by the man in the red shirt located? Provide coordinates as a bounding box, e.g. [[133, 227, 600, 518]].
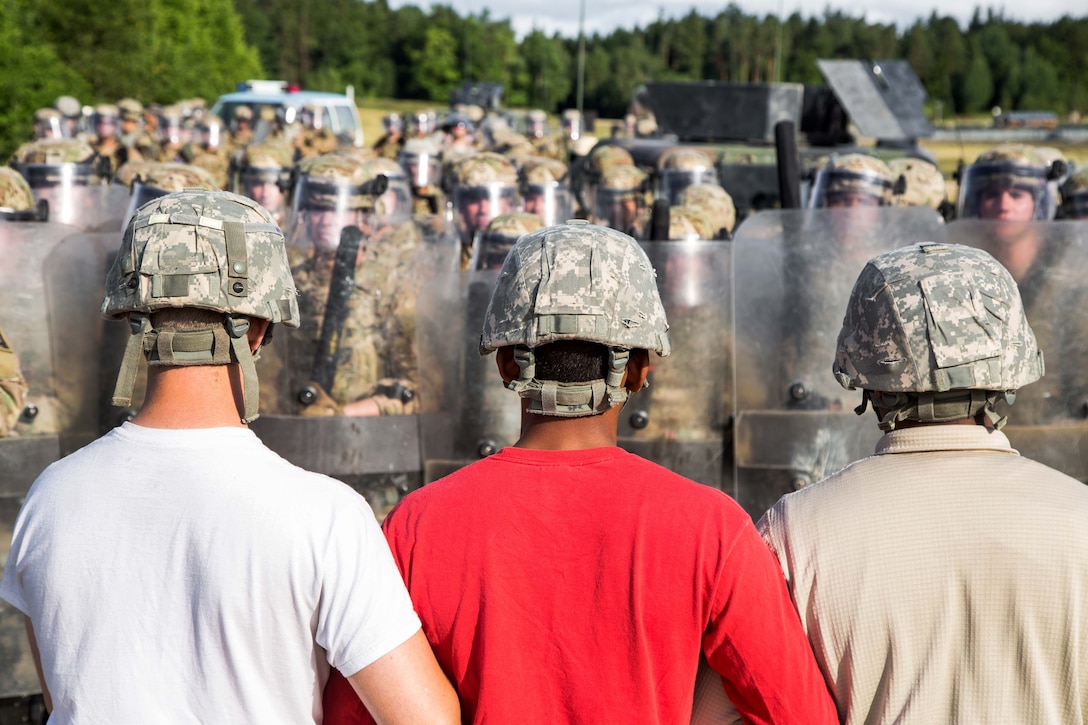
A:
[[480, 222, 671, 417]]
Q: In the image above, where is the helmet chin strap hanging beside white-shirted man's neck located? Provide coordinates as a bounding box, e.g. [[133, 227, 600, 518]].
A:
[[113, 312, 260, 423]]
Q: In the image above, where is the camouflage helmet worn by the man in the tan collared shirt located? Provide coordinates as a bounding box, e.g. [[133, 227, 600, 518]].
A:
[[832, 242, 1043, 430]]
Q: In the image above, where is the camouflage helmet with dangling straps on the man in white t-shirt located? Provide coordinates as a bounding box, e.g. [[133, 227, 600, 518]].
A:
[[102, 189, 299, 422]]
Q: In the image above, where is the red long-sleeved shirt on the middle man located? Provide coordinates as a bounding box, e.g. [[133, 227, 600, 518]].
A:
[[325, 447, 838, 725]]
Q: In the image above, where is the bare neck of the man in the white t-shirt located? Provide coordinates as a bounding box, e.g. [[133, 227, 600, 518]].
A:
[[133, 365, 245, 429]]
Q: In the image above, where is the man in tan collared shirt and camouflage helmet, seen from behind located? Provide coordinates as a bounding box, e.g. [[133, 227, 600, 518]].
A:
[[757, 243, 1088, 724]]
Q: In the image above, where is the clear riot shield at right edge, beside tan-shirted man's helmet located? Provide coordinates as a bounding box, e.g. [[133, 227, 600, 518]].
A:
[[948, 220, 1088, 483]]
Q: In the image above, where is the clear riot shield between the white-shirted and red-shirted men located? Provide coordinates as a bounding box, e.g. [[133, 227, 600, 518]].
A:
[[251, 220, 460, 517]]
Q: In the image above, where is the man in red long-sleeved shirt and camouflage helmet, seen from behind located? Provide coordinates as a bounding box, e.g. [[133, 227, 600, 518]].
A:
[[325, 222, 837, 725]]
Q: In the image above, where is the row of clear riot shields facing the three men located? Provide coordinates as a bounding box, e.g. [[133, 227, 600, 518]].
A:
[[0, 200, 1088, 698]]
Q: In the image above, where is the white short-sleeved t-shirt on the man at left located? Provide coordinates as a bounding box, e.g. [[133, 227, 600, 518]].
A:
[[0, 423, 420, 725]]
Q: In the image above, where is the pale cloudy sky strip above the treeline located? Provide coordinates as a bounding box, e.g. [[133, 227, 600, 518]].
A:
[[390, 0, 1088, 38]]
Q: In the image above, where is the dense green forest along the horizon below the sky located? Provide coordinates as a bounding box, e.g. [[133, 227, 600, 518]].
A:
[[0, 0, 1088, 152]]
